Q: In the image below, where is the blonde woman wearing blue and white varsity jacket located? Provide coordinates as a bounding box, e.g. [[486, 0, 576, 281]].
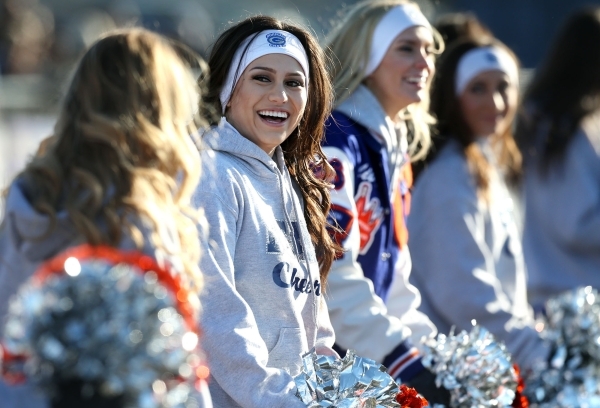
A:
[[323, 0, 449, 403]]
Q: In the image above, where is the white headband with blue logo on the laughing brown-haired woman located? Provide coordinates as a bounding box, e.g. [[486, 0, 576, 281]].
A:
[[219, 30, 309, 113]]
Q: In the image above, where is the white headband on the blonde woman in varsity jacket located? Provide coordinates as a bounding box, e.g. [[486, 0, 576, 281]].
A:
[[365, 3, 431, 77]]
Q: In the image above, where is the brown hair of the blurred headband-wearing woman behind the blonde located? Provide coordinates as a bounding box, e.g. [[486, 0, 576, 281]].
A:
[[428, 38, 521, 198]]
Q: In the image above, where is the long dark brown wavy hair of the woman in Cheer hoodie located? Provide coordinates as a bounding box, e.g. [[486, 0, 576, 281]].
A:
[[204, 16, 341, 282]]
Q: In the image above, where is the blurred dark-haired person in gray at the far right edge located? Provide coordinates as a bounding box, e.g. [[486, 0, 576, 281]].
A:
[[517, 7, 600, 310]]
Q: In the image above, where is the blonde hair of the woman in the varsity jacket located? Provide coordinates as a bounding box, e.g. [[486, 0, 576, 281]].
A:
[[324, 0, 444, 161]]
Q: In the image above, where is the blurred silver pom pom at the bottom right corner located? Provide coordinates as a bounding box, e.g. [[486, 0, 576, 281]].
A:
[[525, 286, 600, 408]]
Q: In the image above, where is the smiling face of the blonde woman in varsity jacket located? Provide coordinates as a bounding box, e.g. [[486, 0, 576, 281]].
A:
[[365, 26, 435, 118]]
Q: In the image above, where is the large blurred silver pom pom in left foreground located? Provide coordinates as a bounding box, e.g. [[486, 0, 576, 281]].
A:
[[3, 258, 202, 408]]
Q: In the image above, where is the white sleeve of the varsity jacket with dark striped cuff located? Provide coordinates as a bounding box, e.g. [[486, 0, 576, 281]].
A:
[[324, 144, 422, 381]]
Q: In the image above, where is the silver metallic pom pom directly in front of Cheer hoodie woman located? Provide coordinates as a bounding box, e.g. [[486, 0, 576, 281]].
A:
[[294, 349, 400, 408]]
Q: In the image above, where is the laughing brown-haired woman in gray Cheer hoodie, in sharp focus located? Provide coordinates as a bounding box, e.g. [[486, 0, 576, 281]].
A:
[[195, 16, 337, 408]]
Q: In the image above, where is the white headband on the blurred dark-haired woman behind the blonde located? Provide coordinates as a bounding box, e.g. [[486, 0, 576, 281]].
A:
[[454, 46, 519, 95]]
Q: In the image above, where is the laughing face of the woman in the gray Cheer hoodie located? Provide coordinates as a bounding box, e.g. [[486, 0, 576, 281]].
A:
[[225, 54, 308, 156]]
